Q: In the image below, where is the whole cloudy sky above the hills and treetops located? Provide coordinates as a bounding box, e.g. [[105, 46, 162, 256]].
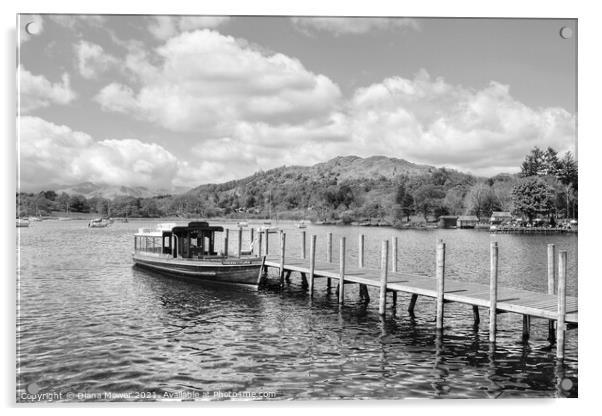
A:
[[17, 15, 577, 191]]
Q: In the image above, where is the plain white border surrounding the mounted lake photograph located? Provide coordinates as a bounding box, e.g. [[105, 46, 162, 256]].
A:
[[0, 0, 602, 416]]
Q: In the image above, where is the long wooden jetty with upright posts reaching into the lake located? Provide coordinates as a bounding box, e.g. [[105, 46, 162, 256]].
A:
[[241, 231, 578, 359]]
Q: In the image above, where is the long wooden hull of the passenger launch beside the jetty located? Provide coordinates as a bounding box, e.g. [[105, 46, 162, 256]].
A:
[[132, 253, 261, 286]]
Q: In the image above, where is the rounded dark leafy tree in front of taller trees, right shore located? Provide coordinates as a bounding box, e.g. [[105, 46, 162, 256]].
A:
[[512, 178, 554, 224]]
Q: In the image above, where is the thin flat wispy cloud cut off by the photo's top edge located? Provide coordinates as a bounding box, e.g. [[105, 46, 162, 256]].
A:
[[291, 17, 420, 36]]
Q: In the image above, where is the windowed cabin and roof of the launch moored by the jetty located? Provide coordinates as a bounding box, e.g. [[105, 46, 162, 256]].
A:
[[134, 221, 224, 259]]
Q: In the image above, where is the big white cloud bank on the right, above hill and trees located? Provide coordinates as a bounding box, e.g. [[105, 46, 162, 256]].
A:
[[349, 71, 576, 175]]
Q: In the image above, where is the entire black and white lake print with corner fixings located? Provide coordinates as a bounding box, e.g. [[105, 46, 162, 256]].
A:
[[14, 13, 576, 407]]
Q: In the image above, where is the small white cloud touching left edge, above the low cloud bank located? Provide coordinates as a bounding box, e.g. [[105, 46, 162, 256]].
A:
[[17, 65, 76, 113]]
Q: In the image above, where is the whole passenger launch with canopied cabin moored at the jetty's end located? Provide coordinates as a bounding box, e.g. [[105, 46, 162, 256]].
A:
[[132, 221, 262, 286]]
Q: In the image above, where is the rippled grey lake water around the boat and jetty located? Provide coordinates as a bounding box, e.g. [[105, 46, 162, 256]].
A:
[[17, 221, 578, 401]]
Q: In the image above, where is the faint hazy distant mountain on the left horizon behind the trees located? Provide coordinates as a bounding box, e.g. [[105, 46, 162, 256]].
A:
[[56, 182, 189, 199]]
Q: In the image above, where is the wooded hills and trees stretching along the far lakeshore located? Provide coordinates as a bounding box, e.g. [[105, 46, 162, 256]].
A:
[[17, 147, 578, 223]]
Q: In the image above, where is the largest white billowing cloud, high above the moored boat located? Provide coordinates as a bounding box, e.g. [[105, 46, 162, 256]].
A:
[[96, 30, 341, 135]]
